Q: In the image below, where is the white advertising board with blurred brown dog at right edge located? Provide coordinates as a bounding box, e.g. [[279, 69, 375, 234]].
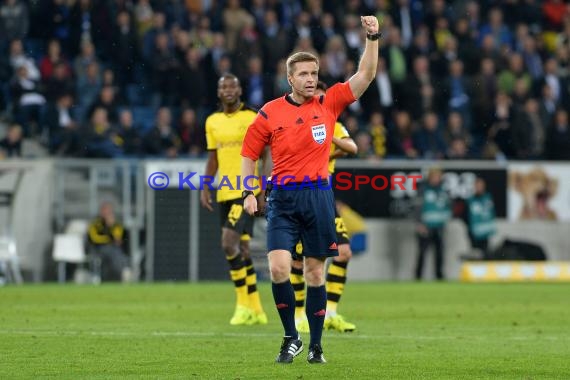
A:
[[507, 162, 570, 221]]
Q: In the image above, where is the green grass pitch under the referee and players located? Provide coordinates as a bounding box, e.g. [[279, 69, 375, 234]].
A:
[[0, 282, 570, 379]]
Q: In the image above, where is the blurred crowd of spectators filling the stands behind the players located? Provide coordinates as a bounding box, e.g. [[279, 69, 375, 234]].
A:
[[0, 0, 570, 160]]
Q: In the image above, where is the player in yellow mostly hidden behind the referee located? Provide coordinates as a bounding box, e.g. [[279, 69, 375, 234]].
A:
[[290, 82, 358, 333]]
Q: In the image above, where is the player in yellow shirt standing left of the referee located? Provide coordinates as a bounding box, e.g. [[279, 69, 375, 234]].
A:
[[200, 74, 267, 325]]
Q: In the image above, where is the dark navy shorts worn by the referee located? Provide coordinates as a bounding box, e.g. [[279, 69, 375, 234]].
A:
[[266, 186, 338, 258]]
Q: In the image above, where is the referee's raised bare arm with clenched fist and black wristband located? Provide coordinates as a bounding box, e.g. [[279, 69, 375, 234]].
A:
[[348, 16, 380, 99]]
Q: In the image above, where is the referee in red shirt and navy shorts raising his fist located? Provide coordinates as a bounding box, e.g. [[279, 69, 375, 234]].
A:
[[241, 16, 380, 363]]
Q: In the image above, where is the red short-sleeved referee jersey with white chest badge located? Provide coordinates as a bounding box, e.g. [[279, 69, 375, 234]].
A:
[[241, 82, 356, 184]]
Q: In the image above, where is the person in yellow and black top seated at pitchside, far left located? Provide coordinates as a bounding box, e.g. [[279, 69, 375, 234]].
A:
[[88, 202, 132, 282]]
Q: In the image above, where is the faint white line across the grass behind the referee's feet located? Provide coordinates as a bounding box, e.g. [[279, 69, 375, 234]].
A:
[[0, 330, 568, 340]]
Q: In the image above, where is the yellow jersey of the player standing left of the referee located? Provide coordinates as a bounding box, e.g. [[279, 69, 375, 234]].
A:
[[206, 103, 259, 203]]
